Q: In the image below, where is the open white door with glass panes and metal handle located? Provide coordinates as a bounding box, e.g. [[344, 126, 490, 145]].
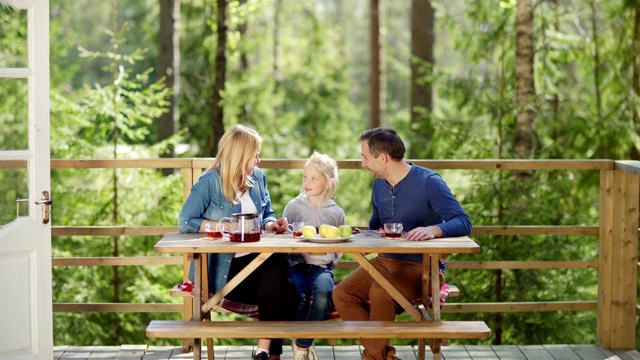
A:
[[0, 0, 53, 360]]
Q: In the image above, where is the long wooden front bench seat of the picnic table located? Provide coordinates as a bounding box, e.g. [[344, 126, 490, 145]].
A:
[[146, 320, 491, 339]]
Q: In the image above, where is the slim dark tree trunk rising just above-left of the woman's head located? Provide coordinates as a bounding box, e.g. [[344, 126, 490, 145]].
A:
[[211, 0, 227, 156]]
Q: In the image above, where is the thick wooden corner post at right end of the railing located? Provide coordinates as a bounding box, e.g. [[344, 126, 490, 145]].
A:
[[597, 163, 640, 349]]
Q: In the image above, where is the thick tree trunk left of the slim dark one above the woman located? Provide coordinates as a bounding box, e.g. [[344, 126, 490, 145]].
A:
[[158, 0, 180, 176]]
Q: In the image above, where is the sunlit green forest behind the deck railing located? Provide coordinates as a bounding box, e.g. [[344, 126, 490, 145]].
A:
[[0, 0, 640, 345]]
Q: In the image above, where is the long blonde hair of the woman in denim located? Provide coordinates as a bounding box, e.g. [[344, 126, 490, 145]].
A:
[[207, 125, 262, 204]]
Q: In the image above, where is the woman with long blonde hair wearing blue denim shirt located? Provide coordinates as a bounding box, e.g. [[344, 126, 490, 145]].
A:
[[178, 125, 297, 360]]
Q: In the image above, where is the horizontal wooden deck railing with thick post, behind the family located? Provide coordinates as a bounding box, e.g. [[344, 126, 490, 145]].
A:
[[0, 158, 640, 349]]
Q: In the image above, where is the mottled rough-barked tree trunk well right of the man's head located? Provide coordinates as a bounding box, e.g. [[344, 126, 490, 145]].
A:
[[514, 0, 536, 162]]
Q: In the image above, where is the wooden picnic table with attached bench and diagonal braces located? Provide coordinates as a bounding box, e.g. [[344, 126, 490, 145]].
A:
[[147, 233, 490, 360]]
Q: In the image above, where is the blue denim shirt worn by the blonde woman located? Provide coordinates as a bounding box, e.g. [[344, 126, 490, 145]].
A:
[[178, 167, 276, 293]]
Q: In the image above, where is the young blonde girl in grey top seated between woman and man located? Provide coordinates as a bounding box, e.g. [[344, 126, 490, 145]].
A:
[[282, 152, 345, 360]]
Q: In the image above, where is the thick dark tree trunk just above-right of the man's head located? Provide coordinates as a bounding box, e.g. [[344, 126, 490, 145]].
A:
[[409, 0, 435, 158]]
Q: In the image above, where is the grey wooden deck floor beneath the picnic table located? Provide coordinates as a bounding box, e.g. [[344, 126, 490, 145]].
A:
[[53, 345, 640, 360]]
